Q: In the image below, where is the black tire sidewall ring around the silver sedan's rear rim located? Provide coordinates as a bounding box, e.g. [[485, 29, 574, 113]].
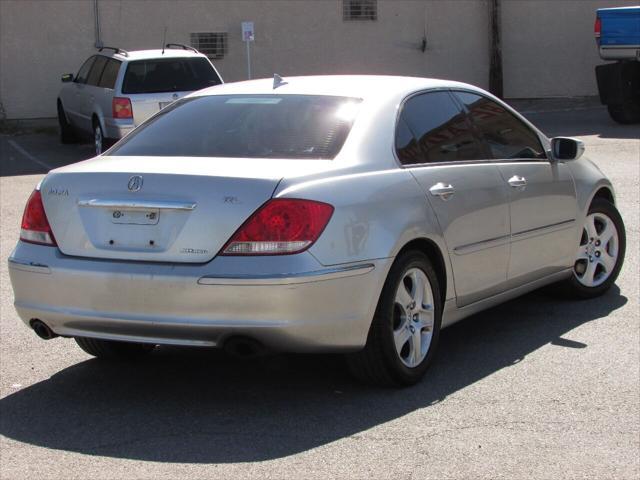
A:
[[376, 251, 442, 385]]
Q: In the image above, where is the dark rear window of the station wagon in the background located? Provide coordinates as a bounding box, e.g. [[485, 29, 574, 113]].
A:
[[122, 58, 222, 94]]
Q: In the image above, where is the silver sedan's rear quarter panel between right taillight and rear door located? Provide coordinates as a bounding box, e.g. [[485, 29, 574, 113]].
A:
[[274, 168, 453, 296]]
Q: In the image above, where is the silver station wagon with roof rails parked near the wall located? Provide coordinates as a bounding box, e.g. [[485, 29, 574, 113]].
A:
[[57, 43, 222, 155]]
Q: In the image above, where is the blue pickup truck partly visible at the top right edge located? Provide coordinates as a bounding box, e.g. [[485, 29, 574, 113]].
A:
[[594, 6, 640, 124]]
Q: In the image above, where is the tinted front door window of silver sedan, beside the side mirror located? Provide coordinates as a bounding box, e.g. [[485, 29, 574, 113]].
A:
[[455, 92, 546, 159]]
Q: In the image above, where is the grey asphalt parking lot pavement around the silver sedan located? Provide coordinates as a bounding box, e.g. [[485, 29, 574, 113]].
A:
[[0, 108, 640, 479]]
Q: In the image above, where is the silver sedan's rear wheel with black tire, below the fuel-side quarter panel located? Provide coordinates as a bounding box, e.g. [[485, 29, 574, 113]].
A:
[[347, 251, 442, 387]]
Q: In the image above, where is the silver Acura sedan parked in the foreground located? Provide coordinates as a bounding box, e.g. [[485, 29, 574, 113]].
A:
[[9, 76, 625, 386]]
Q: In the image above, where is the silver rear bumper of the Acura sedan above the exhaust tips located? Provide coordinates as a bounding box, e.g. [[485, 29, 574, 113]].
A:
[[9, 242, 392, 352]]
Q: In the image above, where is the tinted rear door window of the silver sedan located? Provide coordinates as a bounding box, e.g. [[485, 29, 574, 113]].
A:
[[398, 92, 483, 163]]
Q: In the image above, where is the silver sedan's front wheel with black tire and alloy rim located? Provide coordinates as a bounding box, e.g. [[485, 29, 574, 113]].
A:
[[559, 198, 627, 299]]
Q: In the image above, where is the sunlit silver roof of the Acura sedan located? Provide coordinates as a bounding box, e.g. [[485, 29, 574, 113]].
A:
[[191, 75, 485, 100]]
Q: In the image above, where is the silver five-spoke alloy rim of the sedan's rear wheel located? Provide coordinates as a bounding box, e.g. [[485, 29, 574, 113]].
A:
[[393, 268, 434, 368]]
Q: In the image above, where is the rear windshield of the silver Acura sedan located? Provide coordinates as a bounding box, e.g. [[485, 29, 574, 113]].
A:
[[109, 95, 360, 159]]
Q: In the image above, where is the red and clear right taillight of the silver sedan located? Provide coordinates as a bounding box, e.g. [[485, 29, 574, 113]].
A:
[[222, 198, 333, 255]]
